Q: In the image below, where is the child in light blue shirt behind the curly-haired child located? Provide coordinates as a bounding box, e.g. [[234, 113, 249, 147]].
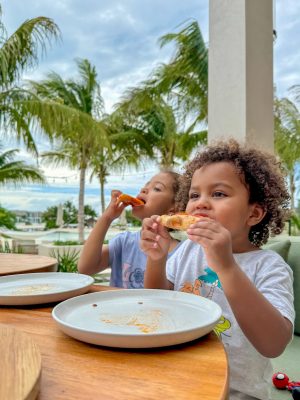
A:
[[78, 170, 181, 289]]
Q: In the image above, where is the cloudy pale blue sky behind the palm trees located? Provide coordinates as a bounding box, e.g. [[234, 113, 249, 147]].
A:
[[0, 0, 300, 211]]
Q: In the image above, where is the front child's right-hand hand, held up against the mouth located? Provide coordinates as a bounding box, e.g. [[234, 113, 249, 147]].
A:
[[187, 217, 235, 273]]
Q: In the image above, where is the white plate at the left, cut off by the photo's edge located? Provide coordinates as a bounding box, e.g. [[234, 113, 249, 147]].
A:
[[0, 272, 94, 306]]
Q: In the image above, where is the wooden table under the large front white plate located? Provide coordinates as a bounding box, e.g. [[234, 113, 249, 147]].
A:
[[0, 285, 228, 400]]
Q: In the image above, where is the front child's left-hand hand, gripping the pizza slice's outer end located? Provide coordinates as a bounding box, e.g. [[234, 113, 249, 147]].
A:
[[140, 215, 172, 260]]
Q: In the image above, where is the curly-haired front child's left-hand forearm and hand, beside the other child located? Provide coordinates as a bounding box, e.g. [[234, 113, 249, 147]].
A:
[[140, 215, 173, 289]]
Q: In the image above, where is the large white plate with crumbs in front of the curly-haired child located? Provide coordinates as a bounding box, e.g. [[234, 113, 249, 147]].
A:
[[52, 289, 221, 348]]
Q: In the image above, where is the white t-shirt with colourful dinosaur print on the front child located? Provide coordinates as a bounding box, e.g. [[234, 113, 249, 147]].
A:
[[167, 240, 295, 400]]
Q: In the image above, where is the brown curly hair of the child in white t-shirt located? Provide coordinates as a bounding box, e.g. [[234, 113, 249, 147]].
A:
[[176, 139, 290, 246]]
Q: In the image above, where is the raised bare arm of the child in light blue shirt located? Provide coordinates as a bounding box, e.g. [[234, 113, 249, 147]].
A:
[[78, 190, 125, 275]]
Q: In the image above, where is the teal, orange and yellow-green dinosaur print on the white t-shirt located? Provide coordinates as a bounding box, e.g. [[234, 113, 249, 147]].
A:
[[180, 267, 231, 338]]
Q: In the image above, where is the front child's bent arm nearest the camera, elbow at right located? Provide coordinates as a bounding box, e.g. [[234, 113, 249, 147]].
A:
[[187, 218, 292, 358]]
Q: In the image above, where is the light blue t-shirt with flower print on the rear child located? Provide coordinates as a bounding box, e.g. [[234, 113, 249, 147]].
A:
[[108, 231, 181, 289]]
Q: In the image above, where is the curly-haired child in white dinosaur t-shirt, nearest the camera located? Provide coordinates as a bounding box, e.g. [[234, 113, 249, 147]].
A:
[[141, 140, 295, 400]]
